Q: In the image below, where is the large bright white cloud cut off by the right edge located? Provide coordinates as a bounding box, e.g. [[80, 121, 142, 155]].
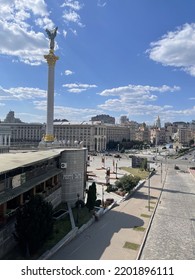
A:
[[147, 23, 195, 76]]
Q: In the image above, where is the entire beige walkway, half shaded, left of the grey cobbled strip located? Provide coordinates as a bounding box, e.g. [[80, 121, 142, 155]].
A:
[[50, 162, 162, 260]]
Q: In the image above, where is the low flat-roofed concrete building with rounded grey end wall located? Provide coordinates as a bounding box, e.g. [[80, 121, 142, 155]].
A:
[[0, 148, 87, 257]]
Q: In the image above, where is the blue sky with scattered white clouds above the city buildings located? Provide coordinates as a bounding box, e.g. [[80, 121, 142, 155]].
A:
[[0, 0, 195, 124]]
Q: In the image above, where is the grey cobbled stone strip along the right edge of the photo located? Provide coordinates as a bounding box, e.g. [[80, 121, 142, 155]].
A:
[[140, 165, 195, 260]]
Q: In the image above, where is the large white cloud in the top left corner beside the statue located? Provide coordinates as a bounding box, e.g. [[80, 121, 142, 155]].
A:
[[0, 0, 53, 65]]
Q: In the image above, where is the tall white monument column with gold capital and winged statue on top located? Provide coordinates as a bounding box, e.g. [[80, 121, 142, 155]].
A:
[[44, 27, 59, 143]]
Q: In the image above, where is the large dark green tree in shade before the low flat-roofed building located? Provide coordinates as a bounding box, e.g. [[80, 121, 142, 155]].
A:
[[14, 196, 53, 256]]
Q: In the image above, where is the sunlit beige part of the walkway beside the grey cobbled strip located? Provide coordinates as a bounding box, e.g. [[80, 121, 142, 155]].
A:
[[101, 166, 163, 260]]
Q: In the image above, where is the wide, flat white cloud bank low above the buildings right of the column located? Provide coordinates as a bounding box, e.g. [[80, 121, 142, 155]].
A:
[[98, 84, 189, 118]]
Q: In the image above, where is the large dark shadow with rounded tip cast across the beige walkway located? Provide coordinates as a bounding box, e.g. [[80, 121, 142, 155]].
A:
[[50, 205, 144, 260]]
